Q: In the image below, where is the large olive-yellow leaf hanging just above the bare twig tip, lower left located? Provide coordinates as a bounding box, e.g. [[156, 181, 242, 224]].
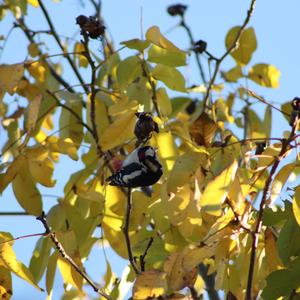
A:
[[12, 163, 42, 216]]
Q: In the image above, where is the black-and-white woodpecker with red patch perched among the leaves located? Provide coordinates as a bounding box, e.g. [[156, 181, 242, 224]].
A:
[[107, 146, 163, 188]]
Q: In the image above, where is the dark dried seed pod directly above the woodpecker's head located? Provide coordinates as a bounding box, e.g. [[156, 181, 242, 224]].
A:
[[134, 112, 159, 143]]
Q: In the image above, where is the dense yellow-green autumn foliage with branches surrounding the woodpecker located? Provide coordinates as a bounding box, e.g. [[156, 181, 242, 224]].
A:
[[0, 0, 300, 299]]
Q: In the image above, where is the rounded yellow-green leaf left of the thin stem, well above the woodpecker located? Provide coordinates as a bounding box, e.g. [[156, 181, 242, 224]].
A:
[[117, 55, 142, 91]]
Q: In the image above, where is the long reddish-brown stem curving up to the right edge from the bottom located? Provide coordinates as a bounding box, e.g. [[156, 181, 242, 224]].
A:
[[246, 118, 298, 300]]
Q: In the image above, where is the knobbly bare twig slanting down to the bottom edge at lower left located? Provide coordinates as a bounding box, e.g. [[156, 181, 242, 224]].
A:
[[36, 212, 111, 300]]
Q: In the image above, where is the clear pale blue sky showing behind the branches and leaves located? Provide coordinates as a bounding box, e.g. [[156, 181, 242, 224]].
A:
[[0, 0, 300, 299]]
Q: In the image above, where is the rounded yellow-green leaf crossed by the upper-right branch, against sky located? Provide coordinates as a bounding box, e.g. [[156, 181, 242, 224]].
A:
[[225, 26, 257, 66]]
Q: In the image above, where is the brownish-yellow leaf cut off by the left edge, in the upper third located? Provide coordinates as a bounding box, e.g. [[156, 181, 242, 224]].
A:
[[0, 64, 24, 95]]
